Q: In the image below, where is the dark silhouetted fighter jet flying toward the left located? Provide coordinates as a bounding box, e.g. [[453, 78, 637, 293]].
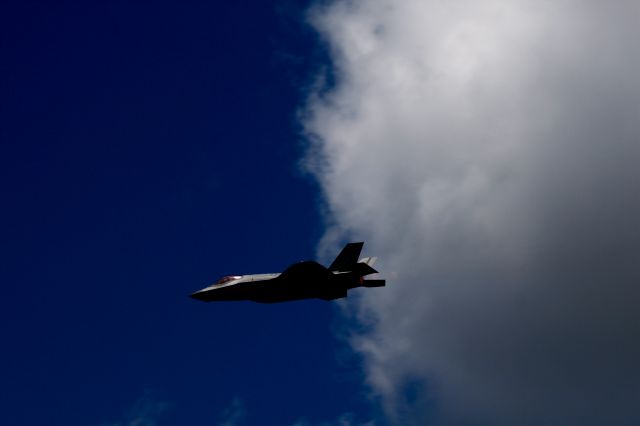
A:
[[191, 243, 385, 303]]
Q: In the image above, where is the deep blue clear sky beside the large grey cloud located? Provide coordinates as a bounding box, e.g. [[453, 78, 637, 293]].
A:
[[0, 1, 369, 426]]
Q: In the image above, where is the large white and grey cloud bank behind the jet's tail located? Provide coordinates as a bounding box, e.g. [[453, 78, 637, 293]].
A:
[[305, 0, 640, 425]]
